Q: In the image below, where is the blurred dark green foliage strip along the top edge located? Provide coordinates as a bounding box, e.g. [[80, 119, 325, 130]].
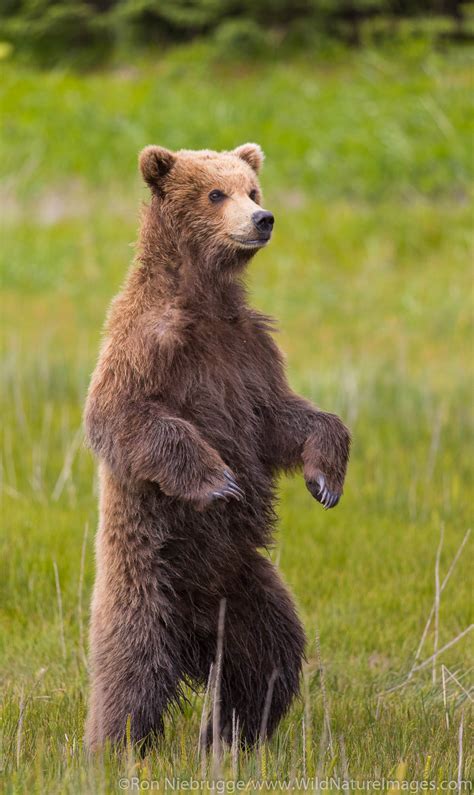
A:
[[0, 0, 473, 67]]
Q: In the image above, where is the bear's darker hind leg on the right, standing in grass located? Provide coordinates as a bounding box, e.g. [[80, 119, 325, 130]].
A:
[[202, 553, 305, 746]]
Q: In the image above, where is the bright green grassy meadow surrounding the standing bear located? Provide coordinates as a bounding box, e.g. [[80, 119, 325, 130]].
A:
[[0, 42, 474, 793]]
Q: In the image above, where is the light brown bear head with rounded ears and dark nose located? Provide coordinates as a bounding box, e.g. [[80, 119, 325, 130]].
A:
[[139, 143, 274, 276]]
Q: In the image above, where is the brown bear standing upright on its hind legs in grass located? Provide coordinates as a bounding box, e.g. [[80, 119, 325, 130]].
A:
[[85, 144, 350, 749]]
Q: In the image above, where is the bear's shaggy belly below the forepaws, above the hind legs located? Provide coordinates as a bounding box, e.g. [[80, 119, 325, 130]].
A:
[[99, 454, 276, 593]]
